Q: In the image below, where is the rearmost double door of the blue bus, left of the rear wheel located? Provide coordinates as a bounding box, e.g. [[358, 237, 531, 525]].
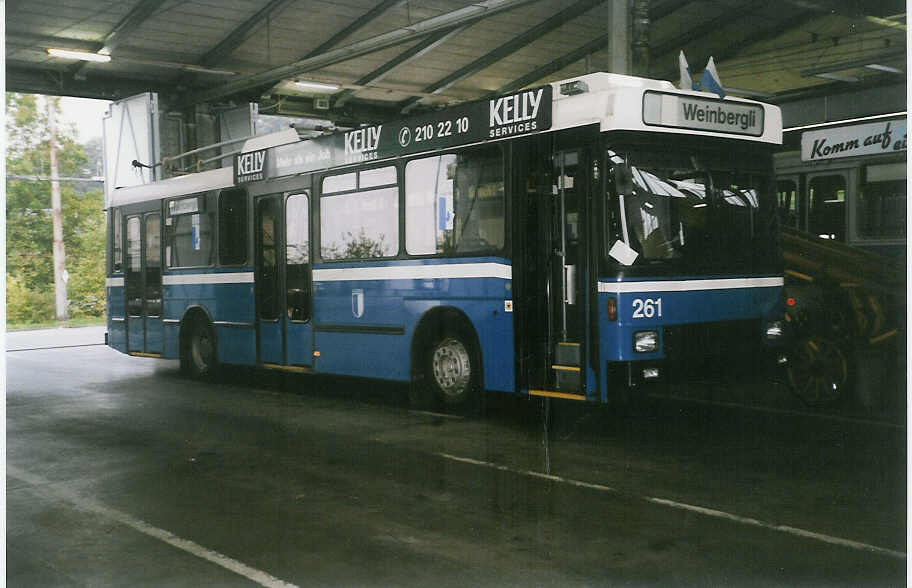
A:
[[124, 213, 162, 354]]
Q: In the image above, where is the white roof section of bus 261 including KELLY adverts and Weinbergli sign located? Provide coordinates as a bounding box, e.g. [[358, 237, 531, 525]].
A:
[[108, 73, 782, 206]]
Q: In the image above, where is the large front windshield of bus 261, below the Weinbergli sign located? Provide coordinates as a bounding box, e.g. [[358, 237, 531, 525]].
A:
[[607, 139, 778, 273]]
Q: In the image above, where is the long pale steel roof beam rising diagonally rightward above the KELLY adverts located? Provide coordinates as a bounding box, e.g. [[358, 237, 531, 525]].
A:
[[183, 0, 537, 104]]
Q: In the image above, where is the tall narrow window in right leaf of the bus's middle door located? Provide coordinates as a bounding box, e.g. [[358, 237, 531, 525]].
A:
[[285, 194, 311, 321]]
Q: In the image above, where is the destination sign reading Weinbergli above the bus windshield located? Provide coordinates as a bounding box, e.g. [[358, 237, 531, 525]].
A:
[[643, 92, 763, 137]]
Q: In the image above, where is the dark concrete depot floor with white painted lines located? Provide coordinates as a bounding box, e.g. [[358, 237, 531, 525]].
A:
[[6, 330, 906, 586]]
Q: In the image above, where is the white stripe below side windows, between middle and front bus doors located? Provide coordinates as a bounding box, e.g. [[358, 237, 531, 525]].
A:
[[313, 263, 513, 282]]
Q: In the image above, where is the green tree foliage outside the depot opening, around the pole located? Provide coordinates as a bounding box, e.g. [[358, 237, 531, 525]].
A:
[[6, 94, 105, 323]]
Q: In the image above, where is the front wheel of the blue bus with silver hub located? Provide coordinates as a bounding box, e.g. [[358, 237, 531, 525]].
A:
[[417, 330, 482, 414]]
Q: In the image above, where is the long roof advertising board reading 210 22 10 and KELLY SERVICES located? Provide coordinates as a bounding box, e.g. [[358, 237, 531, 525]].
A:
[[268, 85, 551, 177]]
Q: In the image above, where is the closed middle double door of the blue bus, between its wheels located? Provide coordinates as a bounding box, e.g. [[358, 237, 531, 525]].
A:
[[255, 193, 313, 367]]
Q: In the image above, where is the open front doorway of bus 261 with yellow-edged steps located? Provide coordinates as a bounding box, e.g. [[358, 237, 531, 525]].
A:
[[514, 142, 588, 397]]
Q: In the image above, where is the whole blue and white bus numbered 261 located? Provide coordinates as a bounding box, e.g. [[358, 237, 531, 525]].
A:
[[107, 73, 783, 409]]
